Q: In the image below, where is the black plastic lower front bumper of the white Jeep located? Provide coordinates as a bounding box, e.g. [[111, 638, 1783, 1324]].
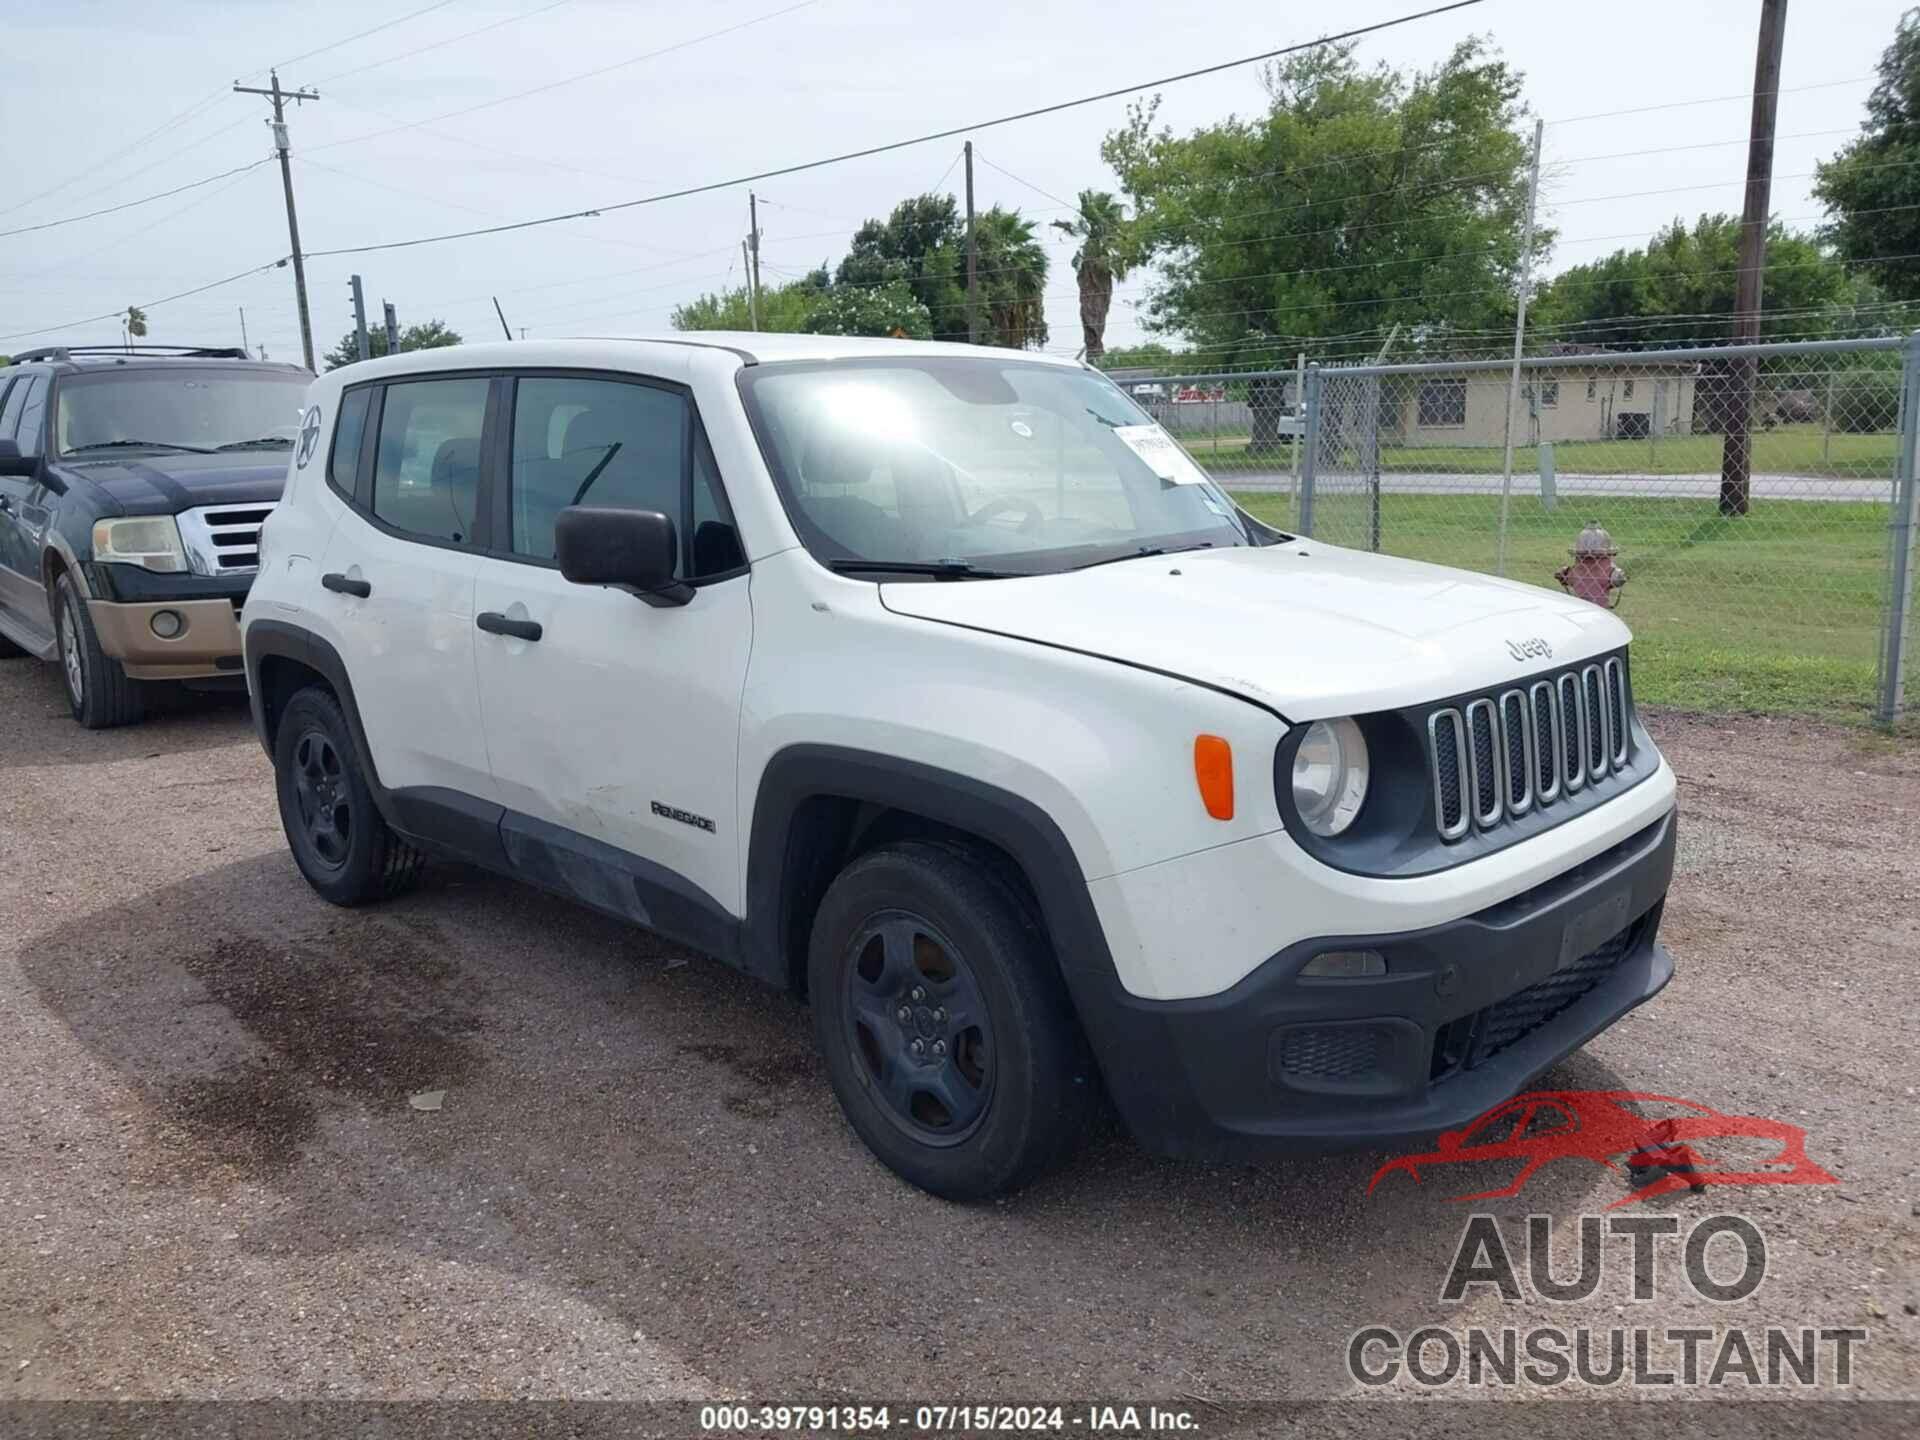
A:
[[1098, 810, 1676, 1160]]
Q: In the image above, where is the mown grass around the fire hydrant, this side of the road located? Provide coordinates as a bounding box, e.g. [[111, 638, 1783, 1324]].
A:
[[1236, 495, 1887, 724]]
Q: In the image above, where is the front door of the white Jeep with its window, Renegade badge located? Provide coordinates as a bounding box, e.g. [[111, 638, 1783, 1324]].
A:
[[474, 374, 753, 913]]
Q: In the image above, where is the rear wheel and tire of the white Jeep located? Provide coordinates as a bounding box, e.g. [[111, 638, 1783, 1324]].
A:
[[273, 685, 424, 904]]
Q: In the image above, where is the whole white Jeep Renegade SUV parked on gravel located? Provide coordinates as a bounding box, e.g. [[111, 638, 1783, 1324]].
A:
[[244, 334, 1674, 1196]]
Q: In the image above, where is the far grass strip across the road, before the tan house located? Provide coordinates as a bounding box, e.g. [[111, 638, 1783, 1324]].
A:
[[1183, 424, 1895, 480]]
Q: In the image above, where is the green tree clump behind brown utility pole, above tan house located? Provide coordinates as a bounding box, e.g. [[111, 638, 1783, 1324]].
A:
[[1528, 215, 1872, 348]]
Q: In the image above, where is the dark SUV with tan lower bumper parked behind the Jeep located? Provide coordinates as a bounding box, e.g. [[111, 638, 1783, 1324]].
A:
[[0, 346, 313, 730]]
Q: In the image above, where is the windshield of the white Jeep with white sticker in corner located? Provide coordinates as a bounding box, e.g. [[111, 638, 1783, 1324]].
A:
[[741, 357, 1269, 576]]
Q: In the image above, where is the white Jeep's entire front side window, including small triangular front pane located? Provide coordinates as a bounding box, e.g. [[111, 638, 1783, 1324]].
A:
[[509, 376, 745, 578]]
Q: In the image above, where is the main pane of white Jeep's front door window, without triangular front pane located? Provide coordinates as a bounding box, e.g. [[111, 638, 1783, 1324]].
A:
[[510, 378, 691, 572]]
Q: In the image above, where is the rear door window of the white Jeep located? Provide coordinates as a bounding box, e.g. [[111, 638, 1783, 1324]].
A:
[[363, 378, 490, 543]]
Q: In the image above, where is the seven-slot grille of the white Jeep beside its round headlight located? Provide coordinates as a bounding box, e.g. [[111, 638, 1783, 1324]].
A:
[[1427, 655, 1632, 841]]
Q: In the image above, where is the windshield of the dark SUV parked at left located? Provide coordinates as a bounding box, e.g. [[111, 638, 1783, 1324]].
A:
[[54, 365, 309, 455]]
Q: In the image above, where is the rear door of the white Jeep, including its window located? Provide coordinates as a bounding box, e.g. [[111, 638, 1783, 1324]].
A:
[[313, 372, 493, 803]]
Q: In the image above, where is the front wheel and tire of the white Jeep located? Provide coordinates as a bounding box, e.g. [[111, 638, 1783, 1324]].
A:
[[806, 841, 1096, 1200]]
